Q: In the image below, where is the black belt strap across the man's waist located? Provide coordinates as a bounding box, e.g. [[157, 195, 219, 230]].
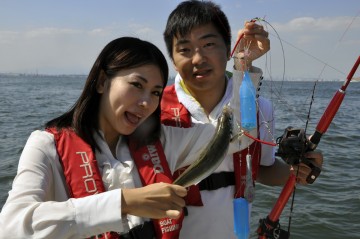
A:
[[198, 172, 235, 190]]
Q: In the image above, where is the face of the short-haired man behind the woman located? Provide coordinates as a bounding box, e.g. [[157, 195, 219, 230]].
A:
[[172, 24, 230, 93]]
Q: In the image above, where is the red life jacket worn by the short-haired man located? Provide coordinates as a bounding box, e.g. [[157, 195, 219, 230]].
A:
[[161, 84, 261, 199]]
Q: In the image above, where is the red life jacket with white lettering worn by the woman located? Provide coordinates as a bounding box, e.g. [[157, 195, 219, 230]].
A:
[[46, 128, 184, 239]]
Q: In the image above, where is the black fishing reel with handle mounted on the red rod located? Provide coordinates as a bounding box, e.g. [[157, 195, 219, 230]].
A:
[[275, 126, 321, 184]]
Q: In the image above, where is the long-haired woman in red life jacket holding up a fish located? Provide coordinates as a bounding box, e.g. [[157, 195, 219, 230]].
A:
[[0, 37, 233, 238]]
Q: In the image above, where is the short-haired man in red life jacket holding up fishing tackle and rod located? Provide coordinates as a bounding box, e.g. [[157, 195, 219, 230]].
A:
[[161, 1, 322, 239]]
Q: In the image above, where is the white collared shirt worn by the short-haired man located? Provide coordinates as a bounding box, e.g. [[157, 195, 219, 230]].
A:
[[175, 67, 275, 239]]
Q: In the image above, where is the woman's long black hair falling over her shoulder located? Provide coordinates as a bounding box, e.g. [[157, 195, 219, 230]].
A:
[[45, 37, 169, 149]]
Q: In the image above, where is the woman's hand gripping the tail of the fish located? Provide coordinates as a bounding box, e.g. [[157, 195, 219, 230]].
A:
[[121, 183, 187, 219]]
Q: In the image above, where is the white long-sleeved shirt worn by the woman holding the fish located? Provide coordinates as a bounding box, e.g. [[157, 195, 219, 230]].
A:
[[0, 116, 249, 239]]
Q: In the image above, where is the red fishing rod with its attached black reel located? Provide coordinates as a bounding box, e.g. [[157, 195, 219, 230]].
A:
[[257, 56, 360, 239]]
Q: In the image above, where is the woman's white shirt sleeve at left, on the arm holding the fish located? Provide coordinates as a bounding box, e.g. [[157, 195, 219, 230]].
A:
[[0, 131, 122, 238]]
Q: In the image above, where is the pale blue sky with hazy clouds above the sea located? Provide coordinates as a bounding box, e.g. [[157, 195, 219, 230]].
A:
[[0, 0, 360, 80]]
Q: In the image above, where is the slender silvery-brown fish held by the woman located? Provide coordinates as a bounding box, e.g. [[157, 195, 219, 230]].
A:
[[173, 105, 233, 187]]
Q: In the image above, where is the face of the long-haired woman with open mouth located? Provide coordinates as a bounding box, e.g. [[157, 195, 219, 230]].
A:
[[97, 65, 164, 143]]
